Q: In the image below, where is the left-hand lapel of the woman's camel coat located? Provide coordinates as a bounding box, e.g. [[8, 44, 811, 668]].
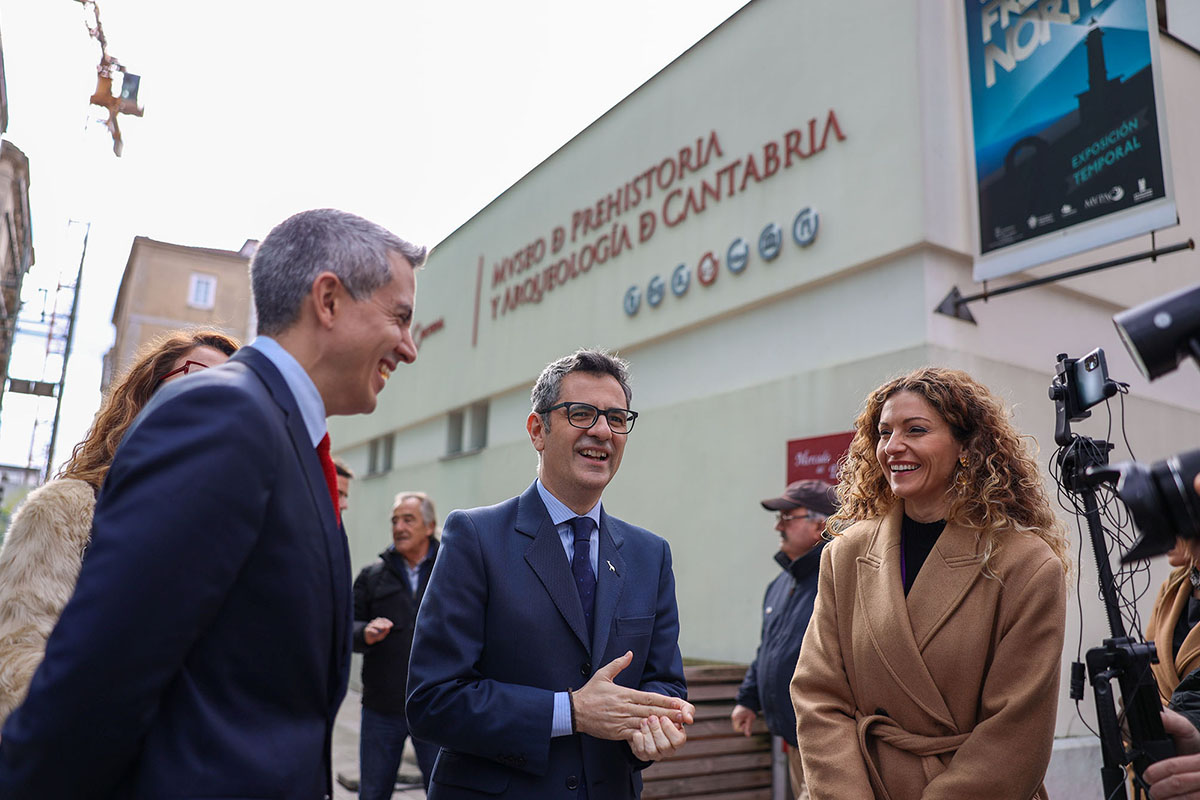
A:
[[857, 504, 956, 730]]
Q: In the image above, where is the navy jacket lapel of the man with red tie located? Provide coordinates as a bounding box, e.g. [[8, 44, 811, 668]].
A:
[[233, 347, 352, 703]]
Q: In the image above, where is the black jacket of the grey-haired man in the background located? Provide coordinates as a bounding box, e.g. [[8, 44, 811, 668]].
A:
[[354, 539, 438, 714]]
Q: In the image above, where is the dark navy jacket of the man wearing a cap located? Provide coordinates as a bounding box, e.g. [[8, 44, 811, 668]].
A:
[[738, 542, 826, 747]]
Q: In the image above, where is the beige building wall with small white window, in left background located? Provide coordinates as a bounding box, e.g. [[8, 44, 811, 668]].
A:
[[101, 236, 253, 391]]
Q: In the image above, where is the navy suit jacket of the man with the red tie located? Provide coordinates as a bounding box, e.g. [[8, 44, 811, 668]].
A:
[[0, 348, 350, 800]]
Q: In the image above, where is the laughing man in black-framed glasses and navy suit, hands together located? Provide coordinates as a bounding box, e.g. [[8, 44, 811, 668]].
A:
[[407, 350, 695, 800]]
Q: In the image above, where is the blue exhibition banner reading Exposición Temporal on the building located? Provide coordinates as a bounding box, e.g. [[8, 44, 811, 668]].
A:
[[964, 0, 1177, 281]]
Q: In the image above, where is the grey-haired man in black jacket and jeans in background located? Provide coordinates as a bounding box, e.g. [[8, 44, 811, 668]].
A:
[[354, 492, 438, 800]]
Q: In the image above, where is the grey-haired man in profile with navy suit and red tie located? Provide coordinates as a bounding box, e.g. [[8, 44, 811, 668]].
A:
[[0, 209, 425, 800]]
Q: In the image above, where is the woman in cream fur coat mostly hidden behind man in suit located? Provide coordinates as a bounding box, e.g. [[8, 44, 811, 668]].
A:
[[0, 330, 238, 724]]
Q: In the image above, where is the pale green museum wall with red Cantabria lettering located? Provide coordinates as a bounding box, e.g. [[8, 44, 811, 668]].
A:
[[331, 0, 1200, 753]]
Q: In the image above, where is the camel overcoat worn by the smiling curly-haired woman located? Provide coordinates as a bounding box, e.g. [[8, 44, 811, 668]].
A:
[[792, 504, 1066, 800]]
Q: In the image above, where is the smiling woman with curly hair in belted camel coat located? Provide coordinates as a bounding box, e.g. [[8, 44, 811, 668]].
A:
[[792, 367, 1068, 800]]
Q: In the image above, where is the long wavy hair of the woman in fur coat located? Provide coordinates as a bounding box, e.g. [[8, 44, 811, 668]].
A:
[[58, 329, 238, 492]]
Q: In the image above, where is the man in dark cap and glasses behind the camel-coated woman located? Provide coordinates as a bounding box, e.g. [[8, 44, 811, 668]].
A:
[[731, 480, 838, 800]]
